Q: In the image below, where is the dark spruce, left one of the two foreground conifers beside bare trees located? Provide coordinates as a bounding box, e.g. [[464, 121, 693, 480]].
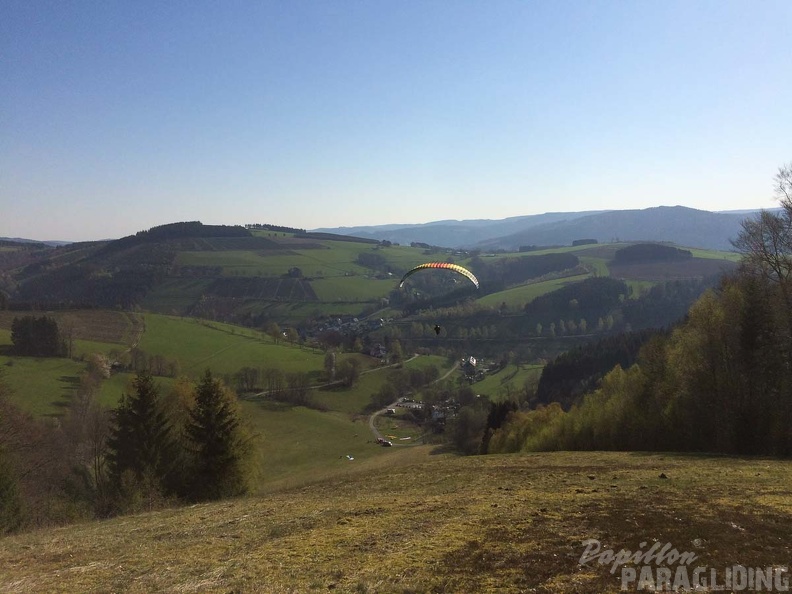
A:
[[108, 372, 179, 509]]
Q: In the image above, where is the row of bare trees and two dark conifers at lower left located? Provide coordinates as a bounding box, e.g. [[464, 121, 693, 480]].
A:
[[0, 370, 253, 534]]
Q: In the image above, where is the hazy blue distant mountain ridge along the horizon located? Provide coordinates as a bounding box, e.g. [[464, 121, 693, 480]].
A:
[[310, 206, 759, 250]]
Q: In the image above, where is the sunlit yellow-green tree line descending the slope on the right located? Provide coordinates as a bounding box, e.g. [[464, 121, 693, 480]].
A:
[[488, 164, 792, 456]]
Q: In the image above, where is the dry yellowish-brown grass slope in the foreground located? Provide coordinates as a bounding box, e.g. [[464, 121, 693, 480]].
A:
[[0, 448, 792, 593]]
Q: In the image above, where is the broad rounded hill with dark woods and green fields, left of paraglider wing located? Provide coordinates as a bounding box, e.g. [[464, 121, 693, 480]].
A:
[[0, 223, 424, 325]]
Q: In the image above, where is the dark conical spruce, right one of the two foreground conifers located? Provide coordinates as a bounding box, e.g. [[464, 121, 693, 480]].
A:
[[186, 369, 247, 501]]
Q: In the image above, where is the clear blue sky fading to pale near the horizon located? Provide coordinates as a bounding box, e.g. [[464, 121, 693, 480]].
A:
[[0, 0, 792, 240]]
